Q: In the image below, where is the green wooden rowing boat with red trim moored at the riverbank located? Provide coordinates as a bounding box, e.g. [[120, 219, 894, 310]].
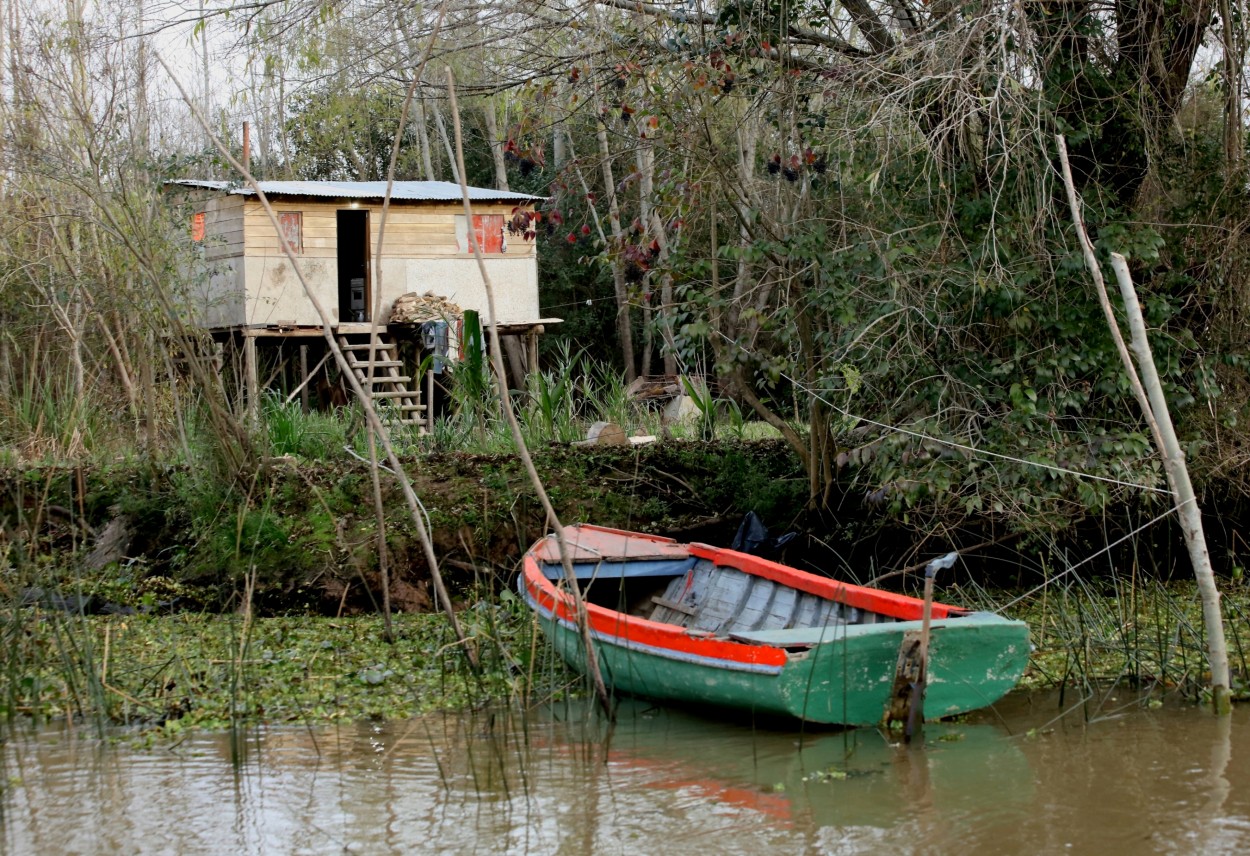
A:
[[519, 525, 1029, 725]]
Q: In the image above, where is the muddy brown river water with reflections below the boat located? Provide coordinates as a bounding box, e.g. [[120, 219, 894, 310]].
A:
[[0, 691, 1250, 855]]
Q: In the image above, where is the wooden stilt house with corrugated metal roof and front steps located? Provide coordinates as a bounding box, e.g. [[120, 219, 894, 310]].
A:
[[174, 180, 558, 421]]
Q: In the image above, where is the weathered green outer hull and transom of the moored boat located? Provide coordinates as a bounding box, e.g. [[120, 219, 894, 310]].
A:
[[539, 614, 1029, 726]]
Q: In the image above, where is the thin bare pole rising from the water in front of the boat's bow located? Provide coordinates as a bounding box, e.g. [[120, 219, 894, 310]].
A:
[[446, 66, 613, 717]]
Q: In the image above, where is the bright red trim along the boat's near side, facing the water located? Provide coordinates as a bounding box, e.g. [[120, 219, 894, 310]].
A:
[[523, 555, 788, 675]]
